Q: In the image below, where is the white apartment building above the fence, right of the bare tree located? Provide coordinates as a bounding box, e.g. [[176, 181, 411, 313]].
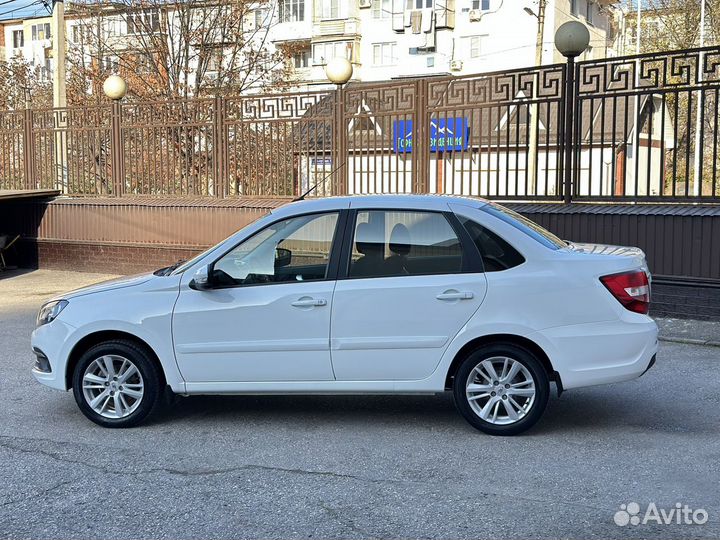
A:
[[272, 0, 616, 86]]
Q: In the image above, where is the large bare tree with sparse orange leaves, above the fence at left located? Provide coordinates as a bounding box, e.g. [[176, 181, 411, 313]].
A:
[[68, 0, 295, 102]]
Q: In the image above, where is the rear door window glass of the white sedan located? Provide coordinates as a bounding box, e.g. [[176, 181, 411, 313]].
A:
[[349, 210, 463, 278]]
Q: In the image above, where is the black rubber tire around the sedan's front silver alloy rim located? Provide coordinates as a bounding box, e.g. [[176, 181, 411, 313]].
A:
[[72, 340, 165, 428]]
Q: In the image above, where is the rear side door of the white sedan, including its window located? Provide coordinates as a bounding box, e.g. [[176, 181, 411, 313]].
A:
[[330, 209, 486, 381]]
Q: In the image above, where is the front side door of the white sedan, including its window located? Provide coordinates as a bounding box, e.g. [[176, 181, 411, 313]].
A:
[[173, 212, 340, 383]]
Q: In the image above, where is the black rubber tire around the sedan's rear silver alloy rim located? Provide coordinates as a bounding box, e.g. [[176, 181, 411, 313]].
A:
[[453, 343, 550, 436]]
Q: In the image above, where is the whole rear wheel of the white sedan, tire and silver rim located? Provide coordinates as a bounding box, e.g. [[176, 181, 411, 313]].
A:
[[453, 344, 550, 435]]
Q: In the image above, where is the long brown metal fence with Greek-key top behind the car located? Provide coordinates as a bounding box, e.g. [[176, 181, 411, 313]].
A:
[[0, 48, 720, 202]]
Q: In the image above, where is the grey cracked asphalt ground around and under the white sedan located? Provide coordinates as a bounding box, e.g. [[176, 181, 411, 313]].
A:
[[0, 271, 720, 539]]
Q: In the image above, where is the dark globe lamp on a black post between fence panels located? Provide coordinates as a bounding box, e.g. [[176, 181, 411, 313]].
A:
[[555, 21, 590, 203]]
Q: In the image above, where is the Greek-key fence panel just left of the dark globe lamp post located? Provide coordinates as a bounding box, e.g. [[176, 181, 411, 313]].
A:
[[422, 65, 565, 200]]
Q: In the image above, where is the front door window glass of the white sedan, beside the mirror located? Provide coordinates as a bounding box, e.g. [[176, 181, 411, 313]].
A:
[[213, 212, 338, 287]]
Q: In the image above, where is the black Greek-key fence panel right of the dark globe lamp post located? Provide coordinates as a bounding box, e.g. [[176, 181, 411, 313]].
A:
[[573, 47, 720, 201]]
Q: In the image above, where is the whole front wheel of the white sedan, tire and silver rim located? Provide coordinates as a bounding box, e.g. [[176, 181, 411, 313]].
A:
[[73, 340, 163, 428]]
